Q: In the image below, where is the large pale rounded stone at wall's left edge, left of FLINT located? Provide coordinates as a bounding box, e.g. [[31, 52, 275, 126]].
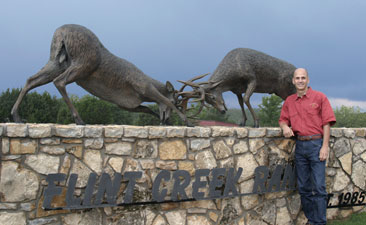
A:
[[0, 162, 39, 202]]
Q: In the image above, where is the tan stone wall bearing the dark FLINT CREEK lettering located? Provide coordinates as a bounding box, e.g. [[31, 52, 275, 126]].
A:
[[0, 123, 366, 225]]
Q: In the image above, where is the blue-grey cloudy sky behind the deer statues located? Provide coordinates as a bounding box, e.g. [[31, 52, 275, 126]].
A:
[[0, 0, 366, 110]]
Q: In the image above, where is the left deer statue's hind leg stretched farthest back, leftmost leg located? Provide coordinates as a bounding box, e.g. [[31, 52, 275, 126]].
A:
[[11, 61, 62, 123]]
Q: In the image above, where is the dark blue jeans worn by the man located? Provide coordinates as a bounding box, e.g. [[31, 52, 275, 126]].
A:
[[295, 139, 327, 225]]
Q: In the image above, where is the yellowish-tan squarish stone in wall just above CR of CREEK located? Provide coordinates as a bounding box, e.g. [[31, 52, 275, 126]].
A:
[[159, 140, 187, 160]]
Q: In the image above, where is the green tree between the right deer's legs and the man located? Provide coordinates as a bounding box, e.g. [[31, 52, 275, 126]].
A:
[[259, 94, 283, 127]]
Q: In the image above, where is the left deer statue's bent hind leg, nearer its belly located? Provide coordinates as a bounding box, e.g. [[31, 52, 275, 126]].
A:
[[53, 65, 89, 125]]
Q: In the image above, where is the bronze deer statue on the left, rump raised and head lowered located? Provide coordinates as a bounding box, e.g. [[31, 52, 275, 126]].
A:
[[11, 24, 189, 125]]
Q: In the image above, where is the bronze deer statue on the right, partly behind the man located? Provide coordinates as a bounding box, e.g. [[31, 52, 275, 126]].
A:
[[180, 48, 296, 127]]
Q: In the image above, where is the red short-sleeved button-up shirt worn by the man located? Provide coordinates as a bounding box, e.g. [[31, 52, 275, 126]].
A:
[[279, 87, 336, 136]]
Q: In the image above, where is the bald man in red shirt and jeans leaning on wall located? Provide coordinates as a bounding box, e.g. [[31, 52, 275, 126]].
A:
[[279, 68, 336, 225]]
